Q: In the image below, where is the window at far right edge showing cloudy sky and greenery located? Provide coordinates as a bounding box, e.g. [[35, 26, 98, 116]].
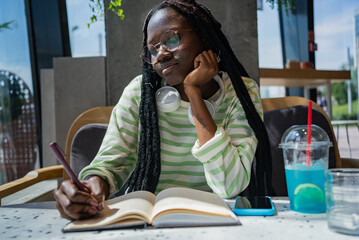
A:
[[314, 0, 359, 120]]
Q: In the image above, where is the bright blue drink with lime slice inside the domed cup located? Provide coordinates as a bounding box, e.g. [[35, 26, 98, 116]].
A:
[[285, 161, 326, 213]]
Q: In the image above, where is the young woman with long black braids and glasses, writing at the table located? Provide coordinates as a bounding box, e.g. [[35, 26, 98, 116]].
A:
[[55, 0, 271, 219]]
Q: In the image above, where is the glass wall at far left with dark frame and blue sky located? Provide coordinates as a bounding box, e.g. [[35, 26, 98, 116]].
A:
[[0, 0, 106, 185]]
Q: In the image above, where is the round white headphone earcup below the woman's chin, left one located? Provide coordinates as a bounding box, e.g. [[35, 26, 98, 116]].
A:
[[156, 86, 181, 112]]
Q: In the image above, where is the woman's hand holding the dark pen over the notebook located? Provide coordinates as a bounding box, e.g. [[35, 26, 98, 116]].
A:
[[54, 176, 108, 220]]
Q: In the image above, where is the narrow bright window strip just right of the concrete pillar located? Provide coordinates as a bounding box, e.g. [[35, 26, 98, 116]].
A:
[[257, 2, 285, 98]]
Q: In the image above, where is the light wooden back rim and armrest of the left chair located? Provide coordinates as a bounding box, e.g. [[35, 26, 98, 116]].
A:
[[0, 106, 113, 203]]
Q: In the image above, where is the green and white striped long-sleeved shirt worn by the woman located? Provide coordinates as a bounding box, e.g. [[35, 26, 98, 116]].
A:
[[80, 73, 263, 198]]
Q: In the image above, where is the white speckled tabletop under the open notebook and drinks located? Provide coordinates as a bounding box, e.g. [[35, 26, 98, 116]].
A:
[[0, 198, 358, 240]]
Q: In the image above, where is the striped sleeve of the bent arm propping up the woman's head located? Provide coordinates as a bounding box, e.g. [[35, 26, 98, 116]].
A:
[[192, 79, 263, 198]]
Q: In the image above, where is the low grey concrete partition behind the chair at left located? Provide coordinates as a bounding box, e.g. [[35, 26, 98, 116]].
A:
[[41, 57, 106, 166]]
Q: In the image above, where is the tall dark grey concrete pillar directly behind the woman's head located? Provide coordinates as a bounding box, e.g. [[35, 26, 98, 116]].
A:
[[105, 0, 259, 105]]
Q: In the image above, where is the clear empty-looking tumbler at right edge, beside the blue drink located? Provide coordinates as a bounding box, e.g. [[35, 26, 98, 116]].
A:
[[325, 168, 359, 235]]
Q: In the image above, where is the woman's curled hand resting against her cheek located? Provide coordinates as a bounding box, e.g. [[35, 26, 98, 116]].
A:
[[183, 50, 218, 88]]
